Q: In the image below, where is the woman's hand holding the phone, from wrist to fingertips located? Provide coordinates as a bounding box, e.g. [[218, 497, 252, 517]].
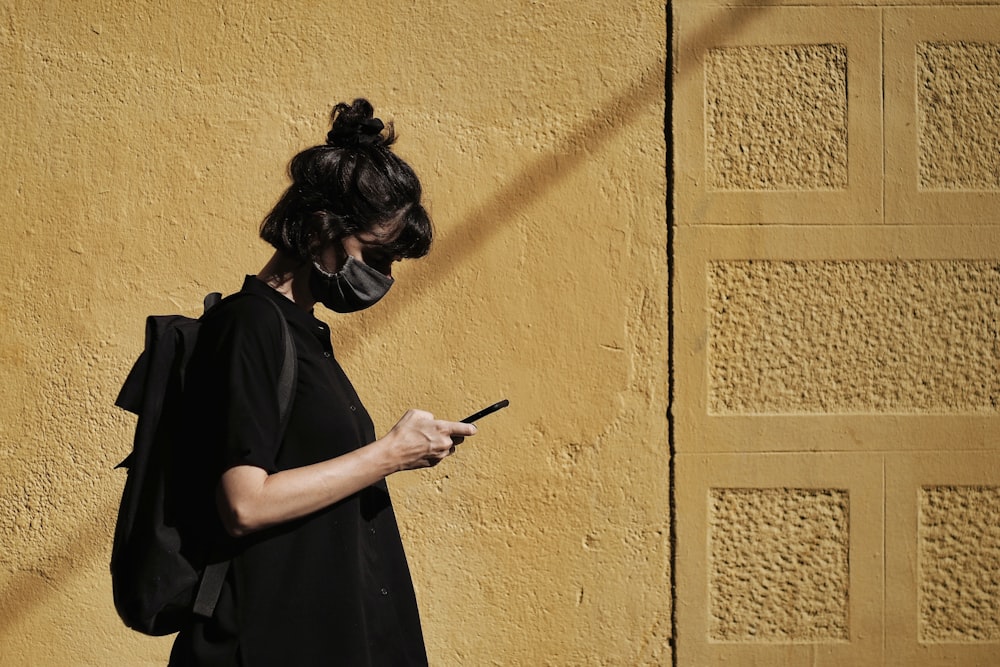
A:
[[381, 410, 476, 470]]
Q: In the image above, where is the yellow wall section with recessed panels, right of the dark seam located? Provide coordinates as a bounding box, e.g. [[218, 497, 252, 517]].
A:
[[672, 0, 1000, 667]]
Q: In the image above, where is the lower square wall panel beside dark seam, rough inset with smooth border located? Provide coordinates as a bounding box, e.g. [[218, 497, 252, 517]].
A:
[[674, 453, 885, 667]]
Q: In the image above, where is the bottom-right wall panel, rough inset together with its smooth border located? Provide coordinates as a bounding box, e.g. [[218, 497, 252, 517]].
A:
[[885, 452, 1000, 667]]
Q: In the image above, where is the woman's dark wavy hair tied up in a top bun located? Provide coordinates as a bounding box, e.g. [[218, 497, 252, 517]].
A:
[[260, 99, 433, 261]]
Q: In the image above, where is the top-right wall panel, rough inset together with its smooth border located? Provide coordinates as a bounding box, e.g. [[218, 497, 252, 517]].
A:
[[883, 3, 1000, 225]]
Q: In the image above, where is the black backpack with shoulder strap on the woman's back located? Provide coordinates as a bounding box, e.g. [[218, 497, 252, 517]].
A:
[[111, 292, 297, 636]]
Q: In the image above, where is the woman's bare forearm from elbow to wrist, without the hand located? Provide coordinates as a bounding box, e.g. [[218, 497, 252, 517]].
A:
[[217, 441, 399, 536]]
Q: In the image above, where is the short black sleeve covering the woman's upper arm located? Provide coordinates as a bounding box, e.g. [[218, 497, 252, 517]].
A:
[[185, 294, 284, 474]]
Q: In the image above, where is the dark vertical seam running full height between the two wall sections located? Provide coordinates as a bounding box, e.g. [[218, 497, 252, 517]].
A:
[[663, 0, 678, 667]]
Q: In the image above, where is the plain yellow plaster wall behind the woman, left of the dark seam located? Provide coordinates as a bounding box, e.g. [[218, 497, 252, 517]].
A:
[[0, 0, 670, 665]]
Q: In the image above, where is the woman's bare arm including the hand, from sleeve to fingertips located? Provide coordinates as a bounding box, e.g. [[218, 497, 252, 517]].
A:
[[216, 410, 476, 536]]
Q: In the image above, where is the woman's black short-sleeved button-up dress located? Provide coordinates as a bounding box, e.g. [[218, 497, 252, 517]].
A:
[[170, 276, 427, 667]]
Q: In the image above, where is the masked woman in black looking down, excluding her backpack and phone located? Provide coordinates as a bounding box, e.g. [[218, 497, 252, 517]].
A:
[[171, 99, 476, 666]]
